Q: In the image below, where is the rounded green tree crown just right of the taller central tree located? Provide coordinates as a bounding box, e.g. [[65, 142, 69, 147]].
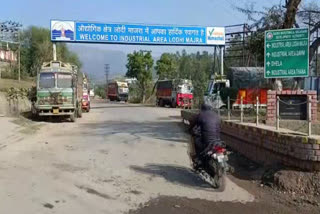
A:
[[155, 53, 178, 80]]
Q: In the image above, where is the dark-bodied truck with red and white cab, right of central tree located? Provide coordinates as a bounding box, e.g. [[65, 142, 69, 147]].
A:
[[156, 79, 193, 108]]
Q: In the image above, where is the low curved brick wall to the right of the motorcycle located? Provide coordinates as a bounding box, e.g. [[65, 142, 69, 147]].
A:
[[221, 121, 320, 171]]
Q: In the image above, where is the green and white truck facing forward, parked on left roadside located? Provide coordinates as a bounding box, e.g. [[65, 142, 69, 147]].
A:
[[32, 61, 83, 122]]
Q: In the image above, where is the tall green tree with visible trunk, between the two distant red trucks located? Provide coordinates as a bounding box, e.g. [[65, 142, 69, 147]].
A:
[[126, 51, 153, 103]]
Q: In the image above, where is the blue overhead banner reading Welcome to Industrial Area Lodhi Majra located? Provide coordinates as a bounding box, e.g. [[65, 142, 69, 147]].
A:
[[51, 20, 225, 46]]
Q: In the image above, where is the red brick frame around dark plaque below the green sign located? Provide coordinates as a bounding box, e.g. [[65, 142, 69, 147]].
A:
[[267, 90, 317, 125]]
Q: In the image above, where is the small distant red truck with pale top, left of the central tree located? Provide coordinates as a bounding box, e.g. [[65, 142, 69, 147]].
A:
[[107, 81, 129, 102]]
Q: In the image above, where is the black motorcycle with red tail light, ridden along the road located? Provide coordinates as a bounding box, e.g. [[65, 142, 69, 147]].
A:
[[189, 127, 229, 190]]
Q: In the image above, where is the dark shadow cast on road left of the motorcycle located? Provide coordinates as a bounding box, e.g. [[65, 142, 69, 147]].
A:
[[130, 164, 212, 190]]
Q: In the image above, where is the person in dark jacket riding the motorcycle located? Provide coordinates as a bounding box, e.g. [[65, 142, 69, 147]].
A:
[[190, 104, 221, 161]]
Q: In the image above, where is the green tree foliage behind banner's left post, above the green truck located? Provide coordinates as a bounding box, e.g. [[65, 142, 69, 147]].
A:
[[21, 26, 81, 76]]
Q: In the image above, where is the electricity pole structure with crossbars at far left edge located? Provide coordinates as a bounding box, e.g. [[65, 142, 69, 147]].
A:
[[0, 21, 22, 81]]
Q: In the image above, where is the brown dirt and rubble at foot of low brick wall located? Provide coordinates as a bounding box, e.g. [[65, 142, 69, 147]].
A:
[[229, 152, 320, 213]]
